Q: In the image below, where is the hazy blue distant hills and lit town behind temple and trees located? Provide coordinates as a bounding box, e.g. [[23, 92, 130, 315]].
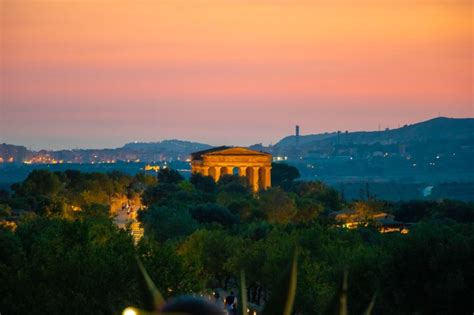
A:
[[0, 117, 474, 200]]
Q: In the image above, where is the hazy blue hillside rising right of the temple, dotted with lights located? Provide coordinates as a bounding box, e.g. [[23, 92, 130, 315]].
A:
[[268, 117, 474, 185]]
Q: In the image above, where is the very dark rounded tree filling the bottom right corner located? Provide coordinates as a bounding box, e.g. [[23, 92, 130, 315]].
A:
[[375, 221, 474, 314]]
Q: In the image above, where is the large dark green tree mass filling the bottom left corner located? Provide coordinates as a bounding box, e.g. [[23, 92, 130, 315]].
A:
[[0, 217, 137, 314]]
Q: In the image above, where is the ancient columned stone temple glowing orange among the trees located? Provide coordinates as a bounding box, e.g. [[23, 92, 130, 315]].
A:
[[191, 147, 272, 191]]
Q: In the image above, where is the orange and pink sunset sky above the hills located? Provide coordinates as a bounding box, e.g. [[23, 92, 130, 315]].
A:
[[0, 0, 474, 149]]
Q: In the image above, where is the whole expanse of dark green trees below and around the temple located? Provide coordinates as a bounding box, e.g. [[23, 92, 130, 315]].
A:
[[0, 170, 474, 314]]
